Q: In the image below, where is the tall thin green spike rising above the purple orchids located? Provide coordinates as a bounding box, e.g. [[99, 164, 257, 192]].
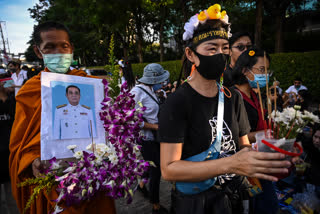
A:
[[105, 34, 120, 98]]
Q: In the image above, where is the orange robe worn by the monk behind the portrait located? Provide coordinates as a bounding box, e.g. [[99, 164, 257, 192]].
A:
[[9, 69, 116, 214]]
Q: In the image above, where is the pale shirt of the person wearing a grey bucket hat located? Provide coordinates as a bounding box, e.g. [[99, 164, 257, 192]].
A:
[[130, 84, 159, 141]]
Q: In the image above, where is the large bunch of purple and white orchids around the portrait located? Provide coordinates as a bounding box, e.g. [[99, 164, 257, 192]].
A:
[[46, 79, 152, 213]]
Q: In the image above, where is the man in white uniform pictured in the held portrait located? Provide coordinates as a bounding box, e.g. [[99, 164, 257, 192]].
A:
[[53, 85, 96, 140]]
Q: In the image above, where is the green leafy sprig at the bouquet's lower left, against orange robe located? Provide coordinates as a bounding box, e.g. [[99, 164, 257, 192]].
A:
[[18, 173, 55, 213]]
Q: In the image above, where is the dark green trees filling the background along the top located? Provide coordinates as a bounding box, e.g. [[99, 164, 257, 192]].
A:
[[26, 0, 319, 66]]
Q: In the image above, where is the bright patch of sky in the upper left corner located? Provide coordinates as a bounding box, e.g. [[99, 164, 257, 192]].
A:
[[0, 0, 38, 54]]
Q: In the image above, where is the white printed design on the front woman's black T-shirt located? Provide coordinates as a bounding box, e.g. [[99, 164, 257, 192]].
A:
[[209, 116, 236, 184]]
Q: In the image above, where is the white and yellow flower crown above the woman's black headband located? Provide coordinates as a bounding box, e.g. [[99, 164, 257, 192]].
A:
[[183, 4, 231, 41]]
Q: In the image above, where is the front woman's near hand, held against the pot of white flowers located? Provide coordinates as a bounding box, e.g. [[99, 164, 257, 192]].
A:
[[231, 148, 291, 181]]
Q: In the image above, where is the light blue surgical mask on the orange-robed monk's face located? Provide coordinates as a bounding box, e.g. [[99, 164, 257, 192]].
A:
[[42, 50, 73, 74]]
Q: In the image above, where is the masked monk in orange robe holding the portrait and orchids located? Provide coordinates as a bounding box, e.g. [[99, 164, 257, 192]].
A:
[[9, 22, 116, 214]]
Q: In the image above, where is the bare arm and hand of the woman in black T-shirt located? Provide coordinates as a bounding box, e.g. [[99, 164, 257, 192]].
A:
[[160, 143, 291, 182]]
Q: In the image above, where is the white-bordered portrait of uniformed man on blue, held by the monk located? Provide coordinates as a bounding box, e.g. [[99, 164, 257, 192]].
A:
[[40, 72, 105, 160]]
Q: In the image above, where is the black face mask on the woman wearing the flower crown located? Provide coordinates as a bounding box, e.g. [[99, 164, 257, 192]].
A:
[[194, 51, 229, 80]]
